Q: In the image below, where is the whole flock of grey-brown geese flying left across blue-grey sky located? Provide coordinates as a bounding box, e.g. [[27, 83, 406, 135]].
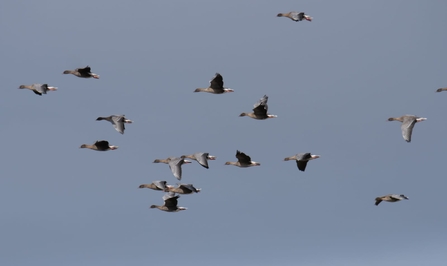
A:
[[19, 11, 447, 212]]
